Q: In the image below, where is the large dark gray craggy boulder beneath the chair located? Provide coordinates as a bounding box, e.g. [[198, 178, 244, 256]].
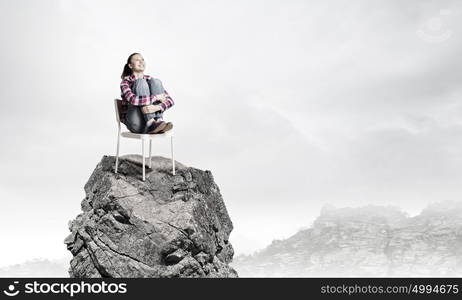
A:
[[64, 155, 237, 278]]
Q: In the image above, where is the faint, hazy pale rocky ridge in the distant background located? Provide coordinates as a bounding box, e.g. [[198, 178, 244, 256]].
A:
[[231, 202, 462, 277]]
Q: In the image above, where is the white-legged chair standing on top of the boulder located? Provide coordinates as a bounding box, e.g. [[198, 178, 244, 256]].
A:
[[114, 99, 175, 181]]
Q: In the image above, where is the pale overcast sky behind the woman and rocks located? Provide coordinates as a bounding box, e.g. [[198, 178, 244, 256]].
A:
[[0, 0, 462, 265]]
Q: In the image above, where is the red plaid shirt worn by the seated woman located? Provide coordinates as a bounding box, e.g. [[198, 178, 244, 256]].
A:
[[120, 74, 174, 112]]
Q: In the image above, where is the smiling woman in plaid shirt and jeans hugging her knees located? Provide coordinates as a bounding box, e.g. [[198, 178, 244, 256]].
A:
[[120, 53, 174, 134]]
